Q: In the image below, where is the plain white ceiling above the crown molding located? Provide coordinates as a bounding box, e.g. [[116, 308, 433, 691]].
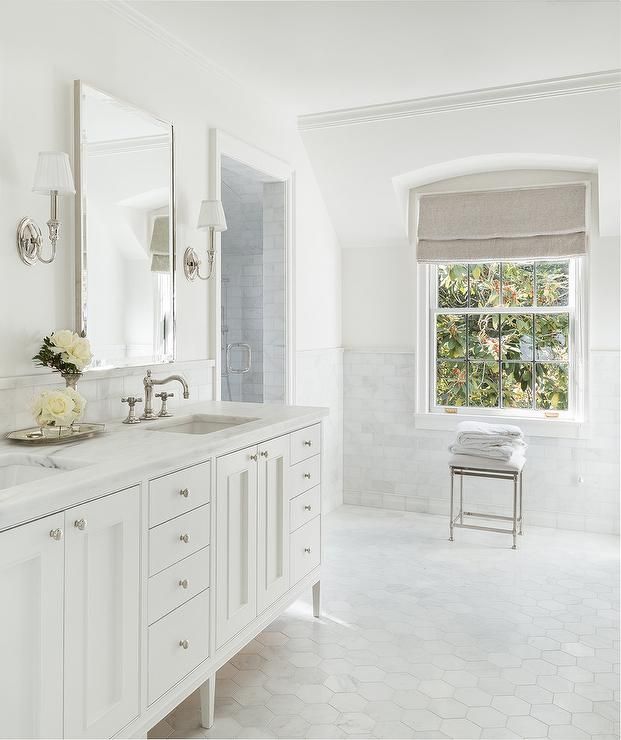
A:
[[130, 0, 619, 115]]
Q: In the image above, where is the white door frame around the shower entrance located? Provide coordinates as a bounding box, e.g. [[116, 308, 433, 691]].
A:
[[209, 129, 295, 403]]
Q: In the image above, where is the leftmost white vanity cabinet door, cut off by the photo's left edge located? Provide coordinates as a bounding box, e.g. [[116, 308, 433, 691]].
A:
[[0, 514, 65, 738]]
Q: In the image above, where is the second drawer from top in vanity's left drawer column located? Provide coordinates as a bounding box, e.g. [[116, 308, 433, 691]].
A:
[[149, 504, 210, 576]]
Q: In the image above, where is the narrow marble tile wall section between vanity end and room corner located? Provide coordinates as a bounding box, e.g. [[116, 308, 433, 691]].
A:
[[295, 347, 343, 513]]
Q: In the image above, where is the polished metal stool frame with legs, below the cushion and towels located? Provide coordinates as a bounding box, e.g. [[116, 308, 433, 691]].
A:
[[449, 465, 524, 550]]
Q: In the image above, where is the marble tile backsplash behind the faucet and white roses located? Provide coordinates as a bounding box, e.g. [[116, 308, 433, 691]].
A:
[[0, 360, 214, 434]]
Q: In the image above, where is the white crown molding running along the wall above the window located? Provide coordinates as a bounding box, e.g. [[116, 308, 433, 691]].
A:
[[298, 69, 621, 131]]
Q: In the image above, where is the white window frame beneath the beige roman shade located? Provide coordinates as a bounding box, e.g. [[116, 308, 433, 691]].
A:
[[416, 257, 587, 422]]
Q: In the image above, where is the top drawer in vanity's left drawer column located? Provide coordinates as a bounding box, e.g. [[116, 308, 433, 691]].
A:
[[149, 462, 211, 527]]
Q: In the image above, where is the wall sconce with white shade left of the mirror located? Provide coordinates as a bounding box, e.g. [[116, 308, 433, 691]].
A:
[[17, 152, 75, 265]]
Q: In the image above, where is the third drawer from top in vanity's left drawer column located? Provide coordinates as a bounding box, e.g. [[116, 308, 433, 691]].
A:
[[148, 547, 209, 624]]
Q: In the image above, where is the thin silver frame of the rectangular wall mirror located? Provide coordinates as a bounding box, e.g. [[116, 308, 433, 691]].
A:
[[73, 80, 177, 371]]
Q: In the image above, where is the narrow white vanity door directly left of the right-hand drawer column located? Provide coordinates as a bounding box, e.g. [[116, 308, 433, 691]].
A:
[[257, 435, 290, 613]]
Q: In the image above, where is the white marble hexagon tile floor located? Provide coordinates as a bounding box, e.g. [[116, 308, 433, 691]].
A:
[[149, 506, 619, 740]]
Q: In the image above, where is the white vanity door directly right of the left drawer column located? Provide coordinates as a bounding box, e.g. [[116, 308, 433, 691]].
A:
[[216, 447, 259, 648]]
